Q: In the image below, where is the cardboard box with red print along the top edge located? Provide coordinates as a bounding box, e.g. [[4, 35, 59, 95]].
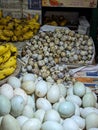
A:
[[42, 0, 97, 8]]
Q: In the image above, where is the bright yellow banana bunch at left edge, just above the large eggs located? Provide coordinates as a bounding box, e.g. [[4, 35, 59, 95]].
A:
[[0, 43, 18, 80]]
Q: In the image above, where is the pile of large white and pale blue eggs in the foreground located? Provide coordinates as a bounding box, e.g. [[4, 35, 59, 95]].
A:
[[0, 73, 98, 130]]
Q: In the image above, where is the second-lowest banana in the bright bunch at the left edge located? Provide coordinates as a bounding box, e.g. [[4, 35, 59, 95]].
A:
[[0, 56, 17, 69]]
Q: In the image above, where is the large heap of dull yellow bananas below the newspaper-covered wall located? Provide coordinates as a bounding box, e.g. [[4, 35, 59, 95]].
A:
[[0, 10, 40, 42]]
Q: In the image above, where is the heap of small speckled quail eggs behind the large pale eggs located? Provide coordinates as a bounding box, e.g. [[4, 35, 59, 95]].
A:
[[21, 28, 94, 82]]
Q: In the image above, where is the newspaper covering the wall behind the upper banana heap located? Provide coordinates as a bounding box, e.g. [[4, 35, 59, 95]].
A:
[[0, 0, 41, 23]]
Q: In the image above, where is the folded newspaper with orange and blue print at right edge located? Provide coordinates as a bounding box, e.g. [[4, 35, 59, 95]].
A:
[[69, 64, 98, 91]]
